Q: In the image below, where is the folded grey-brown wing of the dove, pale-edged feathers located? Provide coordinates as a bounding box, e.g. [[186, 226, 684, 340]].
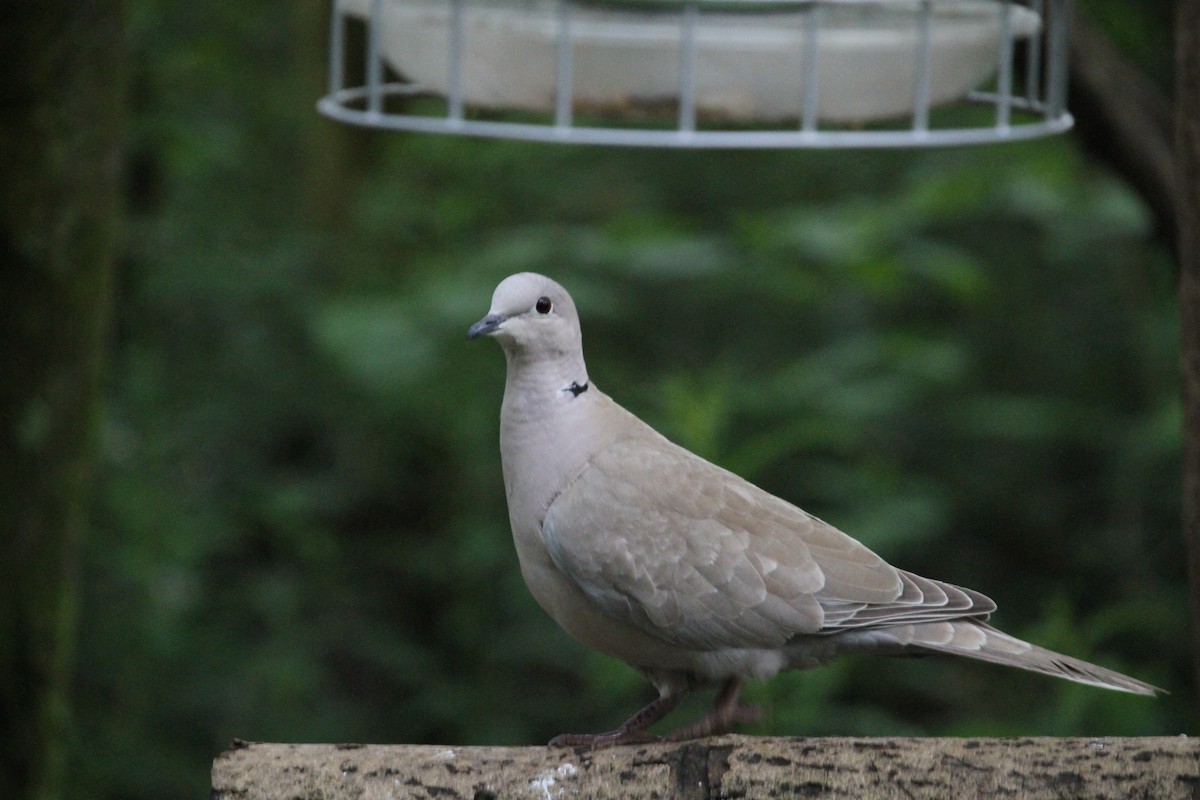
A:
[[542, 434, 991, 650]]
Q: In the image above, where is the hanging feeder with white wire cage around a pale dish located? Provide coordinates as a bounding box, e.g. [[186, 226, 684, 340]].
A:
[[318, 0, 1073, 148]]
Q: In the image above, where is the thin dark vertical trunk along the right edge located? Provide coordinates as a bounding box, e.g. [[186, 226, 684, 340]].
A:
[[1175, 0, 1200, 729]]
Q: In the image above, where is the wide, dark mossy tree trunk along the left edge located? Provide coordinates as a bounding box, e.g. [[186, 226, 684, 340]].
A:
[[0, 0, 125, 800]]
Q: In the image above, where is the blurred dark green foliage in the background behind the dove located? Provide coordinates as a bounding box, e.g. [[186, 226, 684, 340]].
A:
[[74, 0, 1194, 798]]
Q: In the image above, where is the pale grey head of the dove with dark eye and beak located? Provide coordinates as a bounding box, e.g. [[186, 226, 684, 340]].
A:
[[467, 272, 583, 360]]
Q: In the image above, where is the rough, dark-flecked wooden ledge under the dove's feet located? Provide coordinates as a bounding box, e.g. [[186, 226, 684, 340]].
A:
[[212, 735, 1200, 800]]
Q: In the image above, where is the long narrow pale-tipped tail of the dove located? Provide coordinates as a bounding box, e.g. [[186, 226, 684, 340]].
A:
[[896, 620, 1163, 696]]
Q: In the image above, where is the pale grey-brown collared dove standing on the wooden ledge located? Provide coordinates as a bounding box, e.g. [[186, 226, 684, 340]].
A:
[[468, 272, 1157, 746]]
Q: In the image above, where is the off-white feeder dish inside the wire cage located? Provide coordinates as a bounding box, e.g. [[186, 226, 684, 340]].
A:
[[346, 0, 1040, 124]]
